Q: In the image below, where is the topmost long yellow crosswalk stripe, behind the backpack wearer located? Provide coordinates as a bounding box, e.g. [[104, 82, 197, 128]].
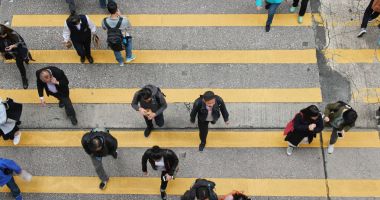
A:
[[12, 13, 320, 27]]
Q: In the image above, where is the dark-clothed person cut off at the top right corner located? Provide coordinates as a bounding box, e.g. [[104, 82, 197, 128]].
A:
[[357, 0, 380, 38]]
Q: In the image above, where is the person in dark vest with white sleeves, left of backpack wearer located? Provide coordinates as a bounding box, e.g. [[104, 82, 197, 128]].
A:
[[63, 14, 98, 64]]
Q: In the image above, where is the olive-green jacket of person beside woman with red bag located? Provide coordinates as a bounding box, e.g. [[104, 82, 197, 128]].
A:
[[324, 102, 355, 132]]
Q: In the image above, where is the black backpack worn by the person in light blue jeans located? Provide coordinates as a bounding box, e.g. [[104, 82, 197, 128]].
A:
[[103, 17, 123, 51]]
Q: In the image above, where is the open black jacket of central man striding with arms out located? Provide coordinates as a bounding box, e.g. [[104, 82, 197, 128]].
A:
[[190, 96, 229, 124]]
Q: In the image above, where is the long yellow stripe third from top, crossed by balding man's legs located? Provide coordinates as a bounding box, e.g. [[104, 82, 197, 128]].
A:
[[0, 88, 322, 104]]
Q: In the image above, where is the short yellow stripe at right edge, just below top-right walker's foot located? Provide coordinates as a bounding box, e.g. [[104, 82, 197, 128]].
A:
[[324, 49, 380, 64]]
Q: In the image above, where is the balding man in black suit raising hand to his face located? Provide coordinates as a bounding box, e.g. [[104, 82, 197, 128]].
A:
[[36, 66, 78, 126]]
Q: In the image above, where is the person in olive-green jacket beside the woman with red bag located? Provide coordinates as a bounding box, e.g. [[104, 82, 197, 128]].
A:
[[324, 101, 358, 154]]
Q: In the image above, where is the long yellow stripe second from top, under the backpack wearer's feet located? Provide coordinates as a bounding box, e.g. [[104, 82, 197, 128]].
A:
[[5, 49, 317, 64]]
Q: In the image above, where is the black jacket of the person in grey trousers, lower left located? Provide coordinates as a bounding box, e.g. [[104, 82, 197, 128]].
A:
[[82, 132, 117, 157]]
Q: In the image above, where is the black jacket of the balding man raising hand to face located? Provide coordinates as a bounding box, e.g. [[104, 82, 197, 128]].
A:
[[36, 66, 69, 97]]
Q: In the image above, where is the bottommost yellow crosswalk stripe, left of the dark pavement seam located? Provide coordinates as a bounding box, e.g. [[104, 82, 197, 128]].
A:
[[0, 177, 327, 197]]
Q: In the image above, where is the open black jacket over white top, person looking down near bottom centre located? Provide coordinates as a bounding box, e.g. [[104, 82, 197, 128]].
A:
[[141, 149, 179, 176]]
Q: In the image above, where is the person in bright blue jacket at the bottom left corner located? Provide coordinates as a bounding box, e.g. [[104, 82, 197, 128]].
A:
[[0, 158, 32, 200]]
